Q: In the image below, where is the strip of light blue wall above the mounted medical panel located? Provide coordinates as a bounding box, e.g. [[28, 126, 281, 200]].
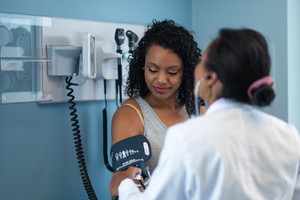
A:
[[0, 0, 191, 27]]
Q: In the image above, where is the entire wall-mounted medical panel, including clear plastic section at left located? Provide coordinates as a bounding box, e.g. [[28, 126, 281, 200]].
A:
[[0, 13, 145, 103]]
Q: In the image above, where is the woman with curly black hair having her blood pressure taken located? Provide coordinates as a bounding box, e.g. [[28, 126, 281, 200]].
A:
[[112, 20, 201, 175]]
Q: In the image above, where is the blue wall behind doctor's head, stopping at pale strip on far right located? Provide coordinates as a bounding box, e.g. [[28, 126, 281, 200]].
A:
[[192, 0, 292, 125]]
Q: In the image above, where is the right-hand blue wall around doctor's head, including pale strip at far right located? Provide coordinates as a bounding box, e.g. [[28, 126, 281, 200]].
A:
[[192, 0, 300, 130]]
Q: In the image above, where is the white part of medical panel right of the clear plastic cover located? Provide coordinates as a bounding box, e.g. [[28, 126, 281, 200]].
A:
[[38, 18, 145, 103]]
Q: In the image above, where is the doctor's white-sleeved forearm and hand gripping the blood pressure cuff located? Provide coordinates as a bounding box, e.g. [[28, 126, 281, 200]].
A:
[[110, 126, 187, 200]]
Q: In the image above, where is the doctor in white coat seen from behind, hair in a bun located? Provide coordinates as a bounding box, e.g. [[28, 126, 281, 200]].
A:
[[110, 29, 300, 200]]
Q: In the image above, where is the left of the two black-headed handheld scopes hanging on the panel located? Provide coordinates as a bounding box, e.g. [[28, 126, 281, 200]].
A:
[[115, 28, 125, 104]]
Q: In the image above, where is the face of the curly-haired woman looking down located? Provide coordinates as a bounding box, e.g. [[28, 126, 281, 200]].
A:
[[145, 45, 183, 100]]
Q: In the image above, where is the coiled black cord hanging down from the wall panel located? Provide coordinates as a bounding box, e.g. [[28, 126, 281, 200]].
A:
[[65, 76, 97, 200]]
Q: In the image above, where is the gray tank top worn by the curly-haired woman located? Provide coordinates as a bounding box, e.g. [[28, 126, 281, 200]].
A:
[[135, 97, 168, 173]]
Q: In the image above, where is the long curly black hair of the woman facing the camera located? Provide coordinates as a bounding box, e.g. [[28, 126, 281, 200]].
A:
[[125, 20, 201, 115]]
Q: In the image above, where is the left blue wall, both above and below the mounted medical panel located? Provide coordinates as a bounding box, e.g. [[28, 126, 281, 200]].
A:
[[0, 0, 191, 200]]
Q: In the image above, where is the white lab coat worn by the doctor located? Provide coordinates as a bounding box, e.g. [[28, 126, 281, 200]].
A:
[[119, 99, 300, 200]]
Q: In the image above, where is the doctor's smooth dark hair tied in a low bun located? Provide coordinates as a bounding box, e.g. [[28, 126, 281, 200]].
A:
[[204, 28, 275, 106]]
